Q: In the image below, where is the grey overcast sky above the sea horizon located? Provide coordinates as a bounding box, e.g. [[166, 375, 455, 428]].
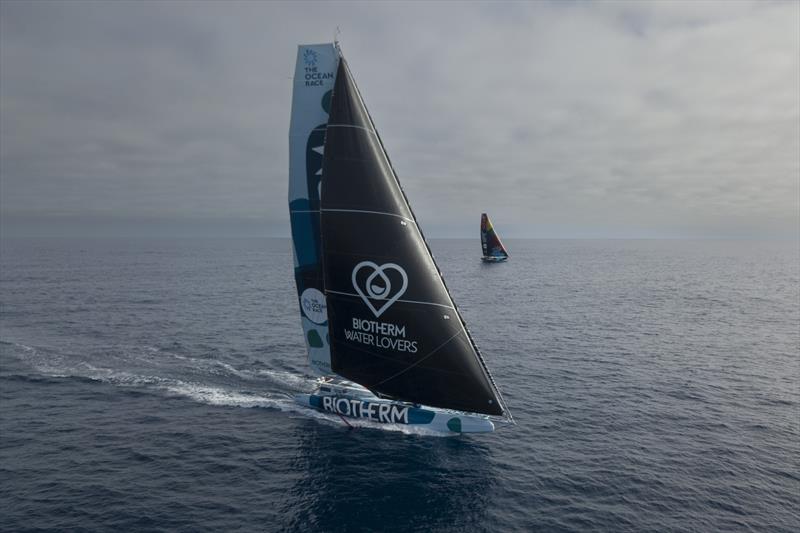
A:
[[0, 0, 800, 238]]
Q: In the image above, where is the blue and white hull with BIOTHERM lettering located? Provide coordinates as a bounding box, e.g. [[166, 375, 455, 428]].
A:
[[295, 394, 494, 434]]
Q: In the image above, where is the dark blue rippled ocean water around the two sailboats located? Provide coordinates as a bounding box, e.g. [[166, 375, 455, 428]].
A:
[[0, 239, 800, 532]]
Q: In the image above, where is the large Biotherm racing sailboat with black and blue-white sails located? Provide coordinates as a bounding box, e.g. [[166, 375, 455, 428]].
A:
[[289, 43, 513, 433]]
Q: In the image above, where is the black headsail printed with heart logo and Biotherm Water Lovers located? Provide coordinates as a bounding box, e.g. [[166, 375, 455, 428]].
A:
[[320, 58, 509, 417]]
